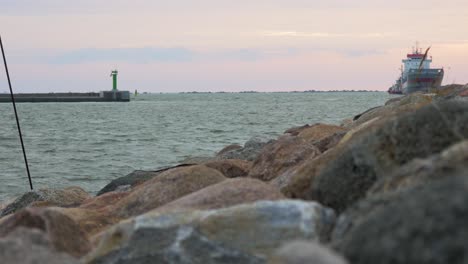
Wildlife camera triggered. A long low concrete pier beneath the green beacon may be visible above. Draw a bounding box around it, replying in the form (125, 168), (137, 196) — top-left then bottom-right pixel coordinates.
(0, 91), (130, 103)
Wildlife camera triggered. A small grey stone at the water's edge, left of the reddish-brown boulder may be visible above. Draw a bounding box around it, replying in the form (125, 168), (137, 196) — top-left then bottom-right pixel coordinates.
(217, 136), (273, 161)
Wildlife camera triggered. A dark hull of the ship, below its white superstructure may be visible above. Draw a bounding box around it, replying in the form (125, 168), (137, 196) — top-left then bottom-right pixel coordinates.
(402, 69), (444, 94)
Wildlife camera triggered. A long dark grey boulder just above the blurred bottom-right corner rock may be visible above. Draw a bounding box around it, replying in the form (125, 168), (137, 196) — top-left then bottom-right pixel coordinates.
(311, 101), (468, 212)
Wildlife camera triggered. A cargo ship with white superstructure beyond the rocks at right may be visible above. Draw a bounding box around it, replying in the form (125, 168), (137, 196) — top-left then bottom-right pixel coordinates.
(388, 45), (444, 94)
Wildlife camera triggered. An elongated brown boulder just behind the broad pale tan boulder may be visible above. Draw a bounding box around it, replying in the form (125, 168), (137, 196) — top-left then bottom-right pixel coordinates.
(113, 165), (226, 218)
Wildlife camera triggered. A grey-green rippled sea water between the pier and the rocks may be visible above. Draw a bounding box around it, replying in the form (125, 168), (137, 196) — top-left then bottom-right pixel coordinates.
(0, 92), (391, 201)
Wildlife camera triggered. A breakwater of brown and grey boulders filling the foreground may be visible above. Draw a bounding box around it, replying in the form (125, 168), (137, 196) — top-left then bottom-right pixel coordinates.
(0, 85), (468, 264)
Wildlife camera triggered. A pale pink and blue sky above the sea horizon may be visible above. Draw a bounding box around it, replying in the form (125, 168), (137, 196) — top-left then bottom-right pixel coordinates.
(0, 0), (468, 92)
